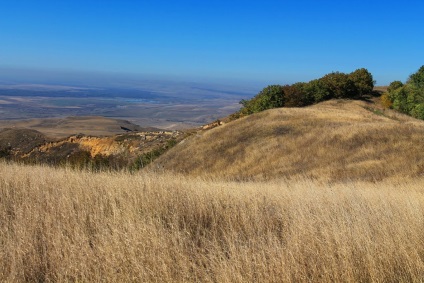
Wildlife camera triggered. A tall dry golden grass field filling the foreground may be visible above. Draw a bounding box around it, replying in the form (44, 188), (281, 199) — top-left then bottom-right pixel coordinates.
(0, 163), (424, 282)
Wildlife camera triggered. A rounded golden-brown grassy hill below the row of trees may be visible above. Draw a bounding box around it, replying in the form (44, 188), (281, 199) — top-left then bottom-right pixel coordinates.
(154, 100), (424, 181)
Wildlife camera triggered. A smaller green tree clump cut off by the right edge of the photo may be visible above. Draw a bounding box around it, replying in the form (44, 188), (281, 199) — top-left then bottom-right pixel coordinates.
(382, 66), (424, 119)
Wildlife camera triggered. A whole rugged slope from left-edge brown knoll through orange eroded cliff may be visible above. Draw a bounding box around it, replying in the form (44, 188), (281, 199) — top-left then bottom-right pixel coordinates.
(0, 128), (184, 169)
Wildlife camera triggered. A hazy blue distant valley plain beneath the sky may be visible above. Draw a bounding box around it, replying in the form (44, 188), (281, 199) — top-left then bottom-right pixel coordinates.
(0, 81), (256, 130)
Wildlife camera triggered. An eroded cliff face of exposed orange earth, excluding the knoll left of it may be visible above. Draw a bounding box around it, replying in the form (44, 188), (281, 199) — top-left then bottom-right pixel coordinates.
(2, 131), (184, 167)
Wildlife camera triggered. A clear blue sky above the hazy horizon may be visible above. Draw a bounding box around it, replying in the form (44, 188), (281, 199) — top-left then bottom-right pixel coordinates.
(0, 0), (424, 85)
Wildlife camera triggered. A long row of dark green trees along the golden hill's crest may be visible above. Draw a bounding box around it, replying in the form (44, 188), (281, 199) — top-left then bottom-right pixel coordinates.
(236, 68), (374, 117)
